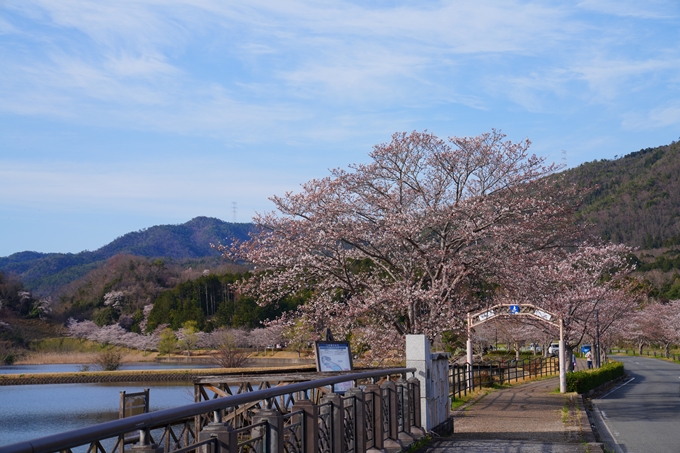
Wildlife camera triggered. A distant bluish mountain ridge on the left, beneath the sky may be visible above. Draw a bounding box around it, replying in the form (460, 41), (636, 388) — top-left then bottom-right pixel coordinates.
(0, 217), (253, 295)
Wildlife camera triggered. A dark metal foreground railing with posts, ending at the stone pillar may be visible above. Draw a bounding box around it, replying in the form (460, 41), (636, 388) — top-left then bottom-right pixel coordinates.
(0, 368), (424, 453)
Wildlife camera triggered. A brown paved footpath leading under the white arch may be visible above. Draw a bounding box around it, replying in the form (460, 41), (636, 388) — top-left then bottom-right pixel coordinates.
(427, 378), (602, 453)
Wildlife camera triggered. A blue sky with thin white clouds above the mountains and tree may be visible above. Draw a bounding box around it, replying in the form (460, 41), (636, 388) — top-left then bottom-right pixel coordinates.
(0, 0), (680, 256)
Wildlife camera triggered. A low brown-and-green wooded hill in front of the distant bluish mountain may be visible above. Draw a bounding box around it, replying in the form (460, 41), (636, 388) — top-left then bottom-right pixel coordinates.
(53, 254), (255, 331)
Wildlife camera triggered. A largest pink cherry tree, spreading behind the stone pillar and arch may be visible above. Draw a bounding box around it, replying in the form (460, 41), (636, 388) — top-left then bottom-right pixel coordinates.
(218, 130), (639, 357)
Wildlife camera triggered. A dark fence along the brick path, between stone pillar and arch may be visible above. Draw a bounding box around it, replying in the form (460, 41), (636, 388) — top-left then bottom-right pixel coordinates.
(449, 357), (560, 401)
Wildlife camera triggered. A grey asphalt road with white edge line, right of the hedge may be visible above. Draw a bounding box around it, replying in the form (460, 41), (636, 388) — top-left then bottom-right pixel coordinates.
(592, 357), (680, 453)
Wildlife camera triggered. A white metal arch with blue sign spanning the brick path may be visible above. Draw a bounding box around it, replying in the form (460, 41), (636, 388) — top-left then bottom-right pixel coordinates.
(467, 304), (567, 393)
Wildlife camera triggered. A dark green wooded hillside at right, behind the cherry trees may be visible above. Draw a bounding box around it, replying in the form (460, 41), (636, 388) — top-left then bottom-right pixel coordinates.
(563, 142), (680, 250)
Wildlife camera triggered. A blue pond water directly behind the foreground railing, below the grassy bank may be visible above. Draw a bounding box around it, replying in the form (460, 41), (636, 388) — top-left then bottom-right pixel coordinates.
(0, 382), (194, 445)
